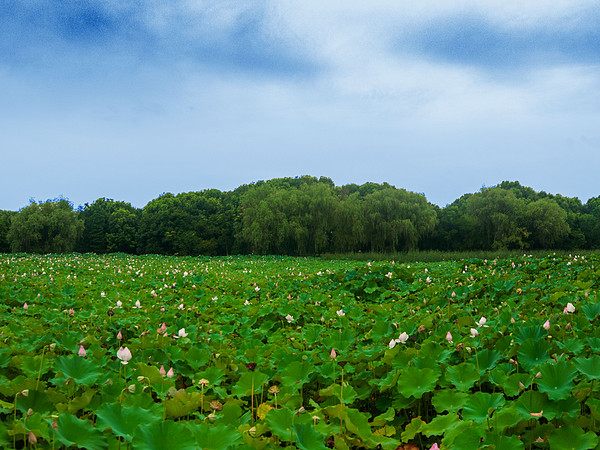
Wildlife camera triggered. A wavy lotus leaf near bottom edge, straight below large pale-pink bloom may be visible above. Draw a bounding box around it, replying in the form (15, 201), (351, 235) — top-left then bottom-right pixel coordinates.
(96, 403), (162, 442)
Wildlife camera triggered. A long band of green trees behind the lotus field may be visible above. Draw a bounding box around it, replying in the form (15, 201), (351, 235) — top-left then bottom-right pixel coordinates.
(0, 176), (600, 255)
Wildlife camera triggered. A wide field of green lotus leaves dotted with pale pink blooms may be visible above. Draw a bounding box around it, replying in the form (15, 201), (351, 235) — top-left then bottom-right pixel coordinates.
(0, 255), (600, 450)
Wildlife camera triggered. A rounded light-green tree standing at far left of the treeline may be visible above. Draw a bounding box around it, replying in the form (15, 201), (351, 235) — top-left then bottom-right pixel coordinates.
(7, 199), (83, 253)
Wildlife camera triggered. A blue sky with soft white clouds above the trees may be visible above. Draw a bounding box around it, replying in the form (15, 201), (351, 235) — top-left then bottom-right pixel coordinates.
(0, 0), (600, 210)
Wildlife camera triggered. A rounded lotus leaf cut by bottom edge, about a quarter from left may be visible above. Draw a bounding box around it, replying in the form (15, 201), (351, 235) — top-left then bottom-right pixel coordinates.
(131, 420), (198, 450)
